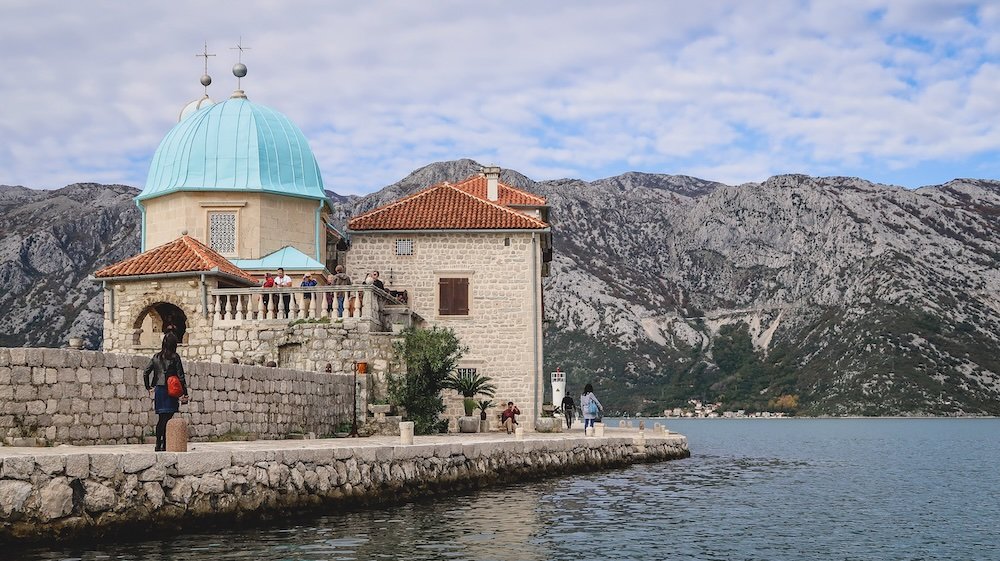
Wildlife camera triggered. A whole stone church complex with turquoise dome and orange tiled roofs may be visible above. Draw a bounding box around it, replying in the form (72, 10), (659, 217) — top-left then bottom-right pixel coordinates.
(93, 66), (552, 427)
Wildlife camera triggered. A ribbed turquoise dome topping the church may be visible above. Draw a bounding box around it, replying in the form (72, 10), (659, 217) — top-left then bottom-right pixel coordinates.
(137, 98), (326, 200)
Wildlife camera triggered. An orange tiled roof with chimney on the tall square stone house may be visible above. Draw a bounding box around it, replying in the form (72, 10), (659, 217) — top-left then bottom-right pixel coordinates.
(347, 177), (549, 231)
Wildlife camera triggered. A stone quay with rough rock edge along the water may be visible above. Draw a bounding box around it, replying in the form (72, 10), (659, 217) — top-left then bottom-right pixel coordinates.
(0, 432), (690, 543)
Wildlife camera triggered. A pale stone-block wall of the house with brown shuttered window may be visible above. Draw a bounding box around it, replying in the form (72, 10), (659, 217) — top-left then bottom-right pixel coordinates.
(348, 231), (545, 427)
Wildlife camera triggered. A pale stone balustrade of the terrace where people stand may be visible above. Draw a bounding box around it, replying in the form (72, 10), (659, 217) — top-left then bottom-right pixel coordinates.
(208, 285), (398, 325)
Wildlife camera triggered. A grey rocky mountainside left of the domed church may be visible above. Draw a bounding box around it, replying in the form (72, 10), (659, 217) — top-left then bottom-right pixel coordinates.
(0, 183), (139, 348)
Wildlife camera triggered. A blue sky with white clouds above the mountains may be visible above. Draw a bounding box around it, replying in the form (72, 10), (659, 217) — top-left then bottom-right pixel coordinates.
(0, 0), (1000, 194)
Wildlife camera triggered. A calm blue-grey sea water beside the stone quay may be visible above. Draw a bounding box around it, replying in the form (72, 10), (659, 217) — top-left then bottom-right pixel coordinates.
(15, 419), (1000, 561)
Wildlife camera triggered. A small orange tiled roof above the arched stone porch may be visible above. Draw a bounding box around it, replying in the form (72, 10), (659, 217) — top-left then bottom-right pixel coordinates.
(94, 236), (254, 282)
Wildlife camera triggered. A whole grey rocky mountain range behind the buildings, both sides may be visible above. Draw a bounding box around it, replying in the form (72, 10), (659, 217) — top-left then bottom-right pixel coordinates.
(0, 160), (1000, 415)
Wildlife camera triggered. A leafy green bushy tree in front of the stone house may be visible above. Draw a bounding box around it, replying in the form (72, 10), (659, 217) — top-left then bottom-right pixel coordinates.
(389, 327), (467, 434)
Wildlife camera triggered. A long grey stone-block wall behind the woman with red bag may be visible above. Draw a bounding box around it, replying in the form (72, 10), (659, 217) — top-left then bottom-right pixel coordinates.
(0, 348), (360, 445)
